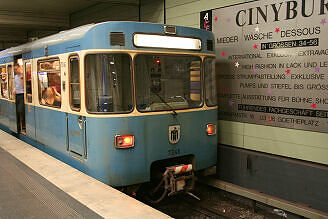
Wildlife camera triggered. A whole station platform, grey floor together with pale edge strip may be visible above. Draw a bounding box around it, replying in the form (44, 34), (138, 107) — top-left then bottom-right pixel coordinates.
(0, 130), (169, 218)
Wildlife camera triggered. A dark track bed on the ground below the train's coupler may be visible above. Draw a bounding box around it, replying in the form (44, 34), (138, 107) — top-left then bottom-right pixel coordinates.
(148, 184), (281, 219)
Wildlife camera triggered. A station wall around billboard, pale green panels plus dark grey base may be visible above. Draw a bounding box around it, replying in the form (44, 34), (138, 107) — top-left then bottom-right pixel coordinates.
(165, 0), (328, 212)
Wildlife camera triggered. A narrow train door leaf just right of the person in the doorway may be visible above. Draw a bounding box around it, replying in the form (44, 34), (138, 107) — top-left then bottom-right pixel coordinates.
(24, 60), (36, 139)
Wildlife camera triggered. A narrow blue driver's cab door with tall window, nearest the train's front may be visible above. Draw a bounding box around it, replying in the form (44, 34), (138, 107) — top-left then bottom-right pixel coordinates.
(66, 55), (87, 158)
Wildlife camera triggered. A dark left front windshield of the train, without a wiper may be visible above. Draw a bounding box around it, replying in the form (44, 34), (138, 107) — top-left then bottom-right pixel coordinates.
(85, 54), (133, 113)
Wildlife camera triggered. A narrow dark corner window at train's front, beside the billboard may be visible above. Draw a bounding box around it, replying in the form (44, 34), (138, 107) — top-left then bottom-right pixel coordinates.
(205, 58), (217, 106)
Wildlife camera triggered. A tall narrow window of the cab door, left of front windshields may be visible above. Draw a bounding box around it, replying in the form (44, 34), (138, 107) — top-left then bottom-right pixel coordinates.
(69, 56), (81, 111)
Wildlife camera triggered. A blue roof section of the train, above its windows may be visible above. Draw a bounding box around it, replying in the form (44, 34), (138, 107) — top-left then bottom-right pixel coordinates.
(0, 21), (214, 63)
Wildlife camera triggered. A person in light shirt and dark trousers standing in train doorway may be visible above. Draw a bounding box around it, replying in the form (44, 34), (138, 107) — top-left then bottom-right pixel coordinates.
(14, 63), (25, 133)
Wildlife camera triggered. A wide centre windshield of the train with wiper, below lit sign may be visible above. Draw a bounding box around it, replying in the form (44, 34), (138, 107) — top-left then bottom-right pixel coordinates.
(134, 54), (203, 112)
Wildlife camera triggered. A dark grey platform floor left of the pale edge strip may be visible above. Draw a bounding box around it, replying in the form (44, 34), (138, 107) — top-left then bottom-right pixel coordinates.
(0, 148), (101, 218)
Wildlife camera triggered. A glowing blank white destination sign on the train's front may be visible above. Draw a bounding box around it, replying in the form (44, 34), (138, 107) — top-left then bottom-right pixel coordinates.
(133, 34), (202, 50)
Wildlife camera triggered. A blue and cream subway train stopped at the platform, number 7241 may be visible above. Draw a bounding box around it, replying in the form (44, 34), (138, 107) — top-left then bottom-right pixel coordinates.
(0, 22), (217, 200)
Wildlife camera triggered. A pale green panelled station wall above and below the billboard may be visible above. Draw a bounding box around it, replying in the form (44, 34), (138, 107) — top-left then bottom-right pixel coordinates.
(166, 0), (328, 165)
